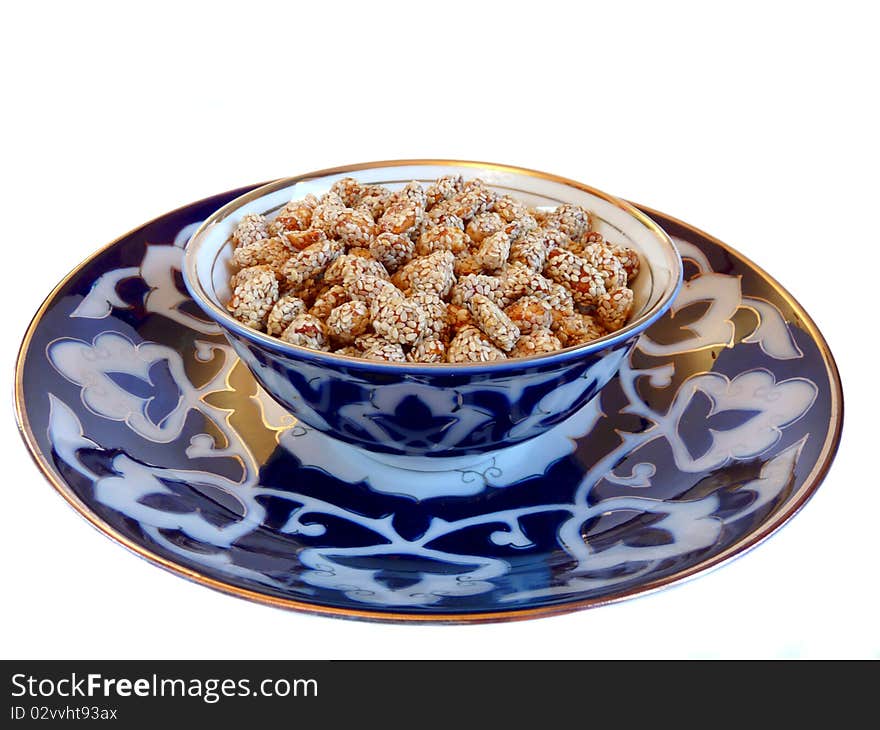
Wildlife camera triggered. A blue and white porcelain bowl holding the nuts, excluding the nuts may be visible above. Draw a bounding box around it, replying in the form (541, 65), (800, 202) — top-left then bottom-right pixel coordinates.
(183, 160), (682, 464)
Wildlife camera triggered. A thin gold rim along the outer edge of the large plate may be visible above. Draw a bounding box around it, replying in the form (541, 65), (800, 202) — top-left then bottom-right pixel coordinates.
(15, 191), (843, 624)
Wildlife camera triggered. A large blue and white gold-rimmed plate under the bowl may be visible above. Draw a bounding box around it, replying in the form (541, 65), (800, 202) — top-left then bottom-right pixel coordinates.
(15, 190), (843, 621)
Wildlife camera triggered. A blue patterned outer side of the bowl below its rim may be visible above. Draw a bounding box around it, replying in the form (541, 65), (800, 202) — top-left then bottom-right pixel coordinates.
(228, 326), (636, 458)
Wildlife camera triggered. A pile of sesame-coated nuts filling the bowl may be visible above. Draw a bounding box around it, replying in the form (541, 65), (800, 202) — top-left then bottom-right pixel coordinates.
(227, 175), (639, 363)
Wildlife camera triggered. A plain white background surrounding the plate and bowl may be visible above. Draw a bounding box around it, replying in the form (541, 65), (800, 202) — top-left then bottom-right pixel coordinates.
(0, 0), (880, 659)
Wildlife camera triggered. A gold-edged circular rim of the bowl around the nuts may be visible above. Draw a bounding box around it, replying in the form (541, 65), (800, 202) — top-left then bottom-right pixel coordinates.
(182, 159), (684, 375)
